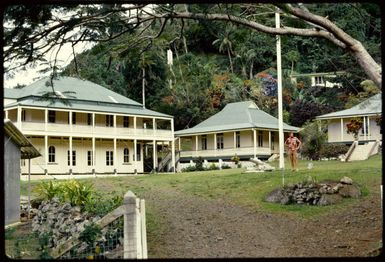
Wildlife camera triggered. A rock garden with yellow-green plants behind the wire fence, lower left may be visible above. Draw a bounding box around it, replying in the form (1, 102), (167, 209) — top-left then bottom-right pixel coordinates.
(21, 181), (123, 259)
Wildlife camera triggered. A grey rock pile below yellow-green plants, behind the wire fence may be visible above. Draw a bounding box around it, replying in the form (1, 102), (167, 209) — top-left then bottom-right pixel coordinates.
(32, 198), (123, 254)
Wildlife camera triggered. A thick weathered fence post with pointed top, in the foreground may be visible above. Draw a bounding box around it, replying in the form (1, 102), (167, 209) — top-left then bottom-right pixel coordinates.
(123, 191), (137, 259)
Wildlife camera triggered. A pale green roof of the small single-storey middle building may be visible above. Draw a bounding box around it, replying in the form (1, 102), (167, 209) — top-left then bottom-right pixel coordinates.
(175, 101), (299, 136)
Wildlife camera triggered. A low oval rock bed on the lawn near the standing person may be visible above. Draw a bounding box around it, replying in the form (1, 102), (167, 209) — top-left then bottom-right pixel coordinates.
(265, 177), (361, 205)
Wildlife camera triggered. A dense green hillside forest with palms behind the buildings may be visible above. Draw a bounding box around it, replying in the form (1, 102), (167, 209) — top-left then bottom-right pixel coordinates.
(58, 3), (381, 130)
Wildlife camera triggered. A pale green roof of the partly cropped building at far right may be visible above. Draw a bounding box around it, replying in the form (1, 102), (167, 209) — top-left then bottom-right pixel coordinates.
(317, 93), (382, 119)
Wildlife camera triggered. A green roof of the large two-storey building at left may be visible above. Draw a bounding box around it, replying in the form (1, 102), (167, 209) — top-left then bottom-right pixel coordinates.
(4, 77), (172, 118)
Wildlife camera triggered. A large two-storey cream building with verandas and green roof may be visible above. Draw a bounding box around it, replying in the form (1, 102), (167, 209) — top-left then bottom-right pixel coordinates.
(4, 77), (175, 174)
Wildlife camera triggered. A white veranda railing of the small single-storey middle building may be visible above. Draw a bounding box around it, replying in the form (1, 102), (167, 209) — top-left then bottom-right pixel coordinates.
(180, 147), (271, 157)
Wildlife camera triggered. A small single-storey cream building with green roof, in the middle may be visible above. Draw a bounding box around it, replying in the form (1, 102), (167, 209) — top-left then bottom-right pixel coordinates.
(175, 101), (299, 169)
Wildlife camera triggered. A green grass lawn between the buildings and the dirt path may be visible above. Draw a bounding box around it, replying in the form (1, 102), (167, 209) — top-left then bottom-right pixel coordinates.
(21, 155), (382, 217)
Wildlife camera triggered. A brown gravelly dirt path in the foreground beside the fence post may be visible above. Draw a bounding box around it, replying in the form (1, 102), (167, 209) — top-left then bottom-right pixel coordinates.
(144, 189), (382, 258)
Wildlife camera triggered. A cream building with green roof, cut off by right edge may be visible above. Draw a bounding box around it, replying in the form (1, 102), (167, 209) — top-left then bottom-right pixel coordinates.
(316, 93), (382, 144)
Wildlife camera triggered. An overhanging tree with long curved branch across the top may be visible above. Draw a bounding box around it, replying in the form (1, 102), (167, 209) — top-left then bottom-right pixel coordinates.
(3, 3), (382, 87)
